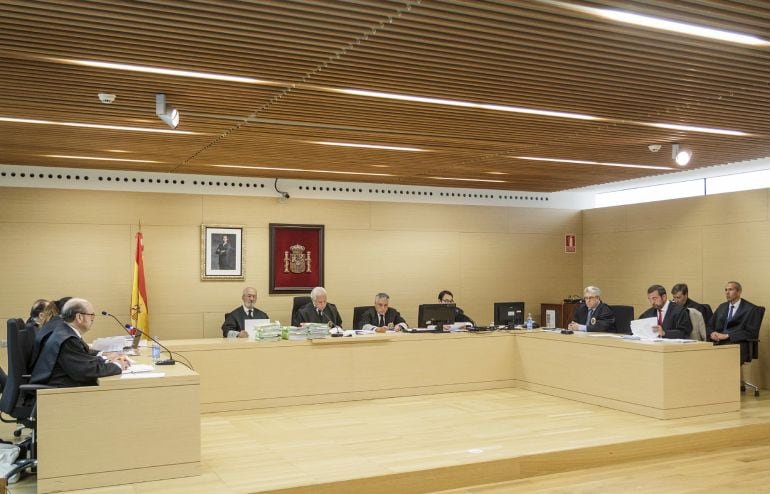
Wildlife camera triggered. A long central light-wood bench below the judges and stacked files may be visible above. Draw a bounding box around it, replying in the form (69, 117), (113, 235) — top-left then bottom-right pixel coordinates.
(166, 333), (515, 412)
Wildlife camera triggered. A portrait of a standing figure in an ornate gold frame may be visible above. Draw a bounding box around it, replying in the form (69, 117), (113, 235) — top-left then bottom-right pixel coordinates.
(201, 225), (244, 280)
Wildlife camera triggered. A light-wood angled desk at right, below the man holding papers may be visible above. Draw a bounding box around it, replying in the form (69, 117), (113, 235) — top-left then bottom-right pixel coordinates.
(516, 332), (740, 418)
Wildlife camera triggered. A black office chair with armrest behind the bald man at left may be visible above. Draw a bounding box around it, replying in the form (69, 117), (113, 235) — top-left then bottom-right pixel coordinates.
(0, 319), (50, 480)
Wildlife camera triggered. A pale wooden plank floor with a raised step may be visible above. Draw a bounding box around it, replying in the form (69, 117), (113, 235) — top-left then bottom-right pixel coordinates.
(8, 388), (770, 494)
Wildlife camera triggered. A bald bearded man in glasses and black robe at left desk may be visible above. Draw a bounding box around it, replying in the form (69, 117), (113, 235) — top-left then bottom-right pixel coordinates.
(30, 298), (129, 388)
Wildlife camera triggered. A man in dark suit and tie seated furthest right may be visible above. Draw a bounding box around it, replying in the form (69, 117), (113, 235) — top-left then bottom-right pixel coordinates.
(707, 281), (762, 362)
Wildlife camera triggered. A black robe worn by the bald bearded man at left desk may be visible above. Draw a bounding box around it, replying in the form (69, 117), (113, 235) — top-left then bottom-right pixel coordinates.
(30, 319), (122, 387)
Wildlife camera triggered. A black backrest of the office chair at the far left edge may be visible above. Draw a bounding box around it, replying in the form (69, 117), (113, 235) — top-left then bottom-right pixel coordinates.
(0, 319), (35, 419)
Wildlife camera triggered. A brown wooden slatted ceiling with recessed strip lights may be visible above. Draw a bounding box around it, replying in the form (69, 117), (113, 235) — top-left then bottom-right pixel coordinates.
(0, 0), (770, 191)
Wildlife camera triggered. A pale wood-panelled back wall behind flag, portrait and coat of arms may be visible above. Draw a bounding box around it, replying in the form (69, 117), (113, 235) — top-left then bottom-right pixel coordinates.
(0, 188), (582, 338)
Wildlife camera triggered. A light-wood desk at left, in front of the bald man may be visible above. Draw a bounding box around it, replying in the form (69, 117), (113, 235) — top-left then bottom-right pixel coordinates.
(37, 365), (200, 493)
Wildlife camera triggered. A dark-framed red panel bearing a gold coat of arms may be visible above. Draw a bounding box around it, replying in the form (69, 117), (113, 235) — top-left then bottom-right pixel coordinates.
(270, 223), (324, 293)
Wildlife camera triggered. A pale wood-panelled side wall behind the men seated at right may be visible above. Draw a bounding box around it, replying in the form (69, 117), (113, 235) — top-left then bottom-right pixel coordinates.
(578, 190), (770, 386)
